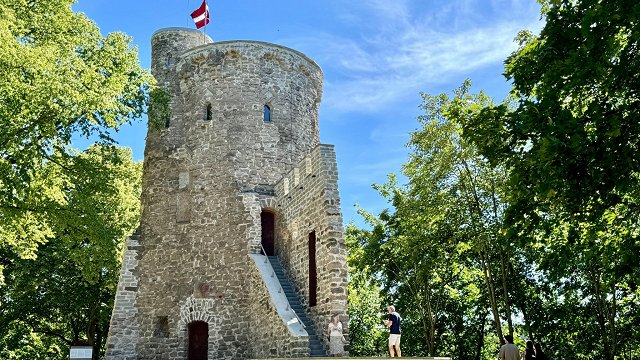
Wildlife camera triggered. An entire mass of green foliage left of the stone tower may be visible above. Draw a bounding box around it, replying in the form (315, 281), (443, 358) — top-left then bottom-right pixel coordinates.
(0, 0), (149, 359)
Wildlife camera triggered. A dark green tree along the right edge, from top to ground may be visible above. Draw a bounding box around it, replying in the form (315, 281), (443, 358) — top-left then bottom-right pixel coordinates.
(464, 0), (640, 359)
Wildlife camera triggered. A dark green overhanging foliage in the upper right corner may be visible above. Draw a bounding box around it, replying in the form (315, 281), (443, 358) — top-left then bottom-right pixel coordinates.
(465, 1), (640, 252)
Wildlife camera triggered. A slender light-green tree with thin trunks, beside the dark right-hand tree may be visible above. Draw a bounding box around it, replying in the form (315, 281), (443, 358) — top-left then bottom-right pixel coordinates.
(403, 81), (524, 346)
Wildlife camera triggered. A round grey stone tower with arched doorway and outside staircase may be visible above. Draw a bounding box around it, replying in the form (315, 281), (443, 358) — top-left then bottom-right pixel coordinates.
(106, 28), (348, 360)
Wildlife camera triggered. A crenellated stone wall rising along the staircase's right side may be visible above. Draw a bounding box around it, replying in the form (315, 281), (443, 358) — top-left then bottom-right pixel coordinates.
(275, 144), (348, 352)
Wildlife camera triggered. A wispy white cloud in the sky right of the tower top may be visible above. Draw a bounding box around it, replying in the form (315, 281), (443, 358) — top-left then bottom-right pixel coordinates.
(288, 0), (540, 112)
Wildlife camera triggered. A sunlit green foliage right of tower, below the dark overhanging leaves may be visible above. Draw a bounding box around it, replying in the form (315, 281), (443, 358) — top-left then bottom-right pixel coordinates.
(349, 62), (640, 359)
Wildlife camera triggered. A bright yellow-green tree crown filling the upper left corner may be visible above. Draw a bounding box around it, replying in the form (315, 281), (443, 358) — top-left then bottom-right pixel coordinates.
(0, 0), (153, 272)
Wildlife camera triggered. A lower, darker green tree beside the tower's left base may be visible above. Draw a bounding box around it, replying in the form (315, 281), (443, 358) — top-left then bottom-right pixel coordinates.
(0, 145), (142, 359)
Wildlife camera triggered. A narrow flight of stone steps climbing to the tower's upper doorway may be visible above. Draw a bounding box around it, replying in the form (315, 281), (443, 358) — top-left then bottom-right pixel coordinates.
(268, 256), (327, 357)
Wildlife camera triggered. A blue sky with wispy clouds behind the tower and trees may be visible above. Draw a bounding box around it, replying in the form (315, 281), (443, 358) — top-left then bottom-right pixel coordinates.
(73, 0), (543, 226)
